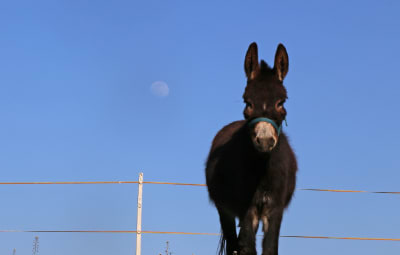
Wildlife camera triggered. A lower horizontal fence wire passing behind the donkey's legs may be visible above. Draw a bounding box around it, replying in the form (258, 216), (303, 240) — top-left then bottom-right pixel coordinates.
(0, 230), (400, 242)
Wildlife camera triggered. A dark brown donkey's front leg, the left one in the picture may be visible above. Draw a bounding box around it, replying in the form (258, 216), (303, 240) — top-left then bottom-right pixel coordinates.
(239, 207), (259, 255)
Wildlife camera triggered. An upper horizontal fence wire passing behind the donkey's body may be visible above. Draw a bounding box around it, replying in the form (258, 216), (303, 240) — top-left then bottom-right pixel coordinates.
(0, 181), (400, 195)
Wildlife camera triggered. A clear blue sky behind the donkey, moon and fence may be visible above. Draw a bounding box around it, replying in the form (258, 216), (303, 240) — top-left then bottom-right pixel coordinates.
(0, 0), (400, 255)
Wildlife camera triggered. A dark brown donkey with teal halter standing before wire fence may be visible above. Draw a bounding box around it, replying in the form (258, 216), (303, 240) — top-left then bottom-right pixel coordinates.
(205, 43), (297, 255)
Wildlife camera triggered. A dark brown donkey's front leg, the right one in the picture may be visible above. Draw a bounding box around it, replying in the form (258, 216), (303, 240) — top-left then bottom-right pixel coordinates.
(262, 210), (283, 255)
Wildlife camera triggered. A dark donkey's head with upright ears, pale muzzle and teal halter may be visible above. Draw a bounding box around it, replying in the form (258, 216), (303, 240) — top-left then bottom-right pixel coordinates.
(243, 43), (289, 152)
